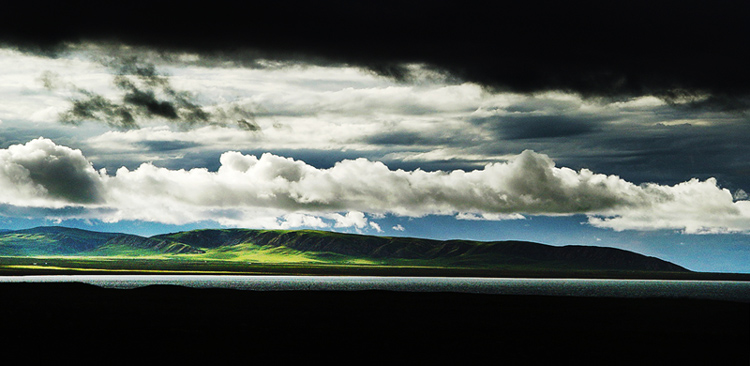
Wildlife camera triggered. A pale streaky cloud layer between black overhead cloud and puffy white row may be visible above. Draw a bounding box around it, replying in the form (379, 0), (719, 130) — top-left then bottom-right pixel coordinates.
(5, 45), (750, 223)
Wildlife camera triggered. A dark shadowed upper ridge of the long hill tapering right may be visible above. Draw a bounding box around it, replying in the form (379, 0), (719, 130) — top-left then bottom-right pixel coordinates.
(152, 229), (687, 271)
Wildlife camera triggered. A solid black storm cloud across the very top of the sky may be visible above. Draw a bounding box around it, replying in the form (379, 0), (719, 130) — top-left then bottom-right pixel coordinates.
(0, 0), (750, 109)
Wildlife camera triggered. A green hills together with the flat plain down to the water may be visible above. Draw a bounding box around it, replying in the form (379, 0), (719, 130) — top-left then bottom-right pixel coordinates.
(0, 227), (748, 278)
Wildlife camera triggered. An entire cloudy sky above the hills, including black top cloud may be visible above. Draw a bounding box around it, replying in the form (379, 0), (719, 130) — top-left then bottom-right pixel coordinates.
(0, 1), (750, 273)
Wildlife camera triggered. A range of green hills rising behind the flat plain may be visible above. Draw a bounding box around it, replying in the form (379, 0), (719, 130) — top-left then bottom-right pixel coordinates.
(0, 226), (688, 272)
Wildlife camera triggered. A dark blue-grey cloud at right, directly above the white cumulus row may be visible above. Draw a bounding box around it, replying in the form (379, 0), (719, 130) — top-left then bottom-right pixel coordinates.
(471, 122), (750, 196)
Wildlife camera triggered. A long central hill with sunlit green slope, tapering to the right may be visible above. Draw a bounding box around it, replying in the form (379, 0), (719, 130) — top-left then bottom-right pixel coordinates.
(157, 229), (684, 271)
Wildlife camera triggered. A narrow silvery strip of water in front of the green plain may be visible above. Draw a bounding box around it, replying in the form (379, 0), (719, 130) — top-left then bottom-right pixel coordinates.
(0, 275), (750, 302)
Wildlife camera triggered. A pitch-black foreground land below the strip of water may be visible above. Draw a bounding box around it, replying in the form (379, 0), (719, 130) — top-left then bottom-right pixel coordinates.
(0, 283), (750, 365)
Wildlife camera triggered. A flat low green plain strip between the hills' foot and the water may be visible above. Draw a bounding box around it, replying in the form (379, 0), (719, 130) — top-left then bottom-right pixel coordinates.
(0, 253), (750, 281)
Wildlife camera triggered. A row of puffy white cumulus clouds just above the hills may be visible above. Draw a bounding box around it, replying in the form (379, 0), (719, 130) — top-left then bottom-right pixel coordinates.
(0, 138), (750, 233)
